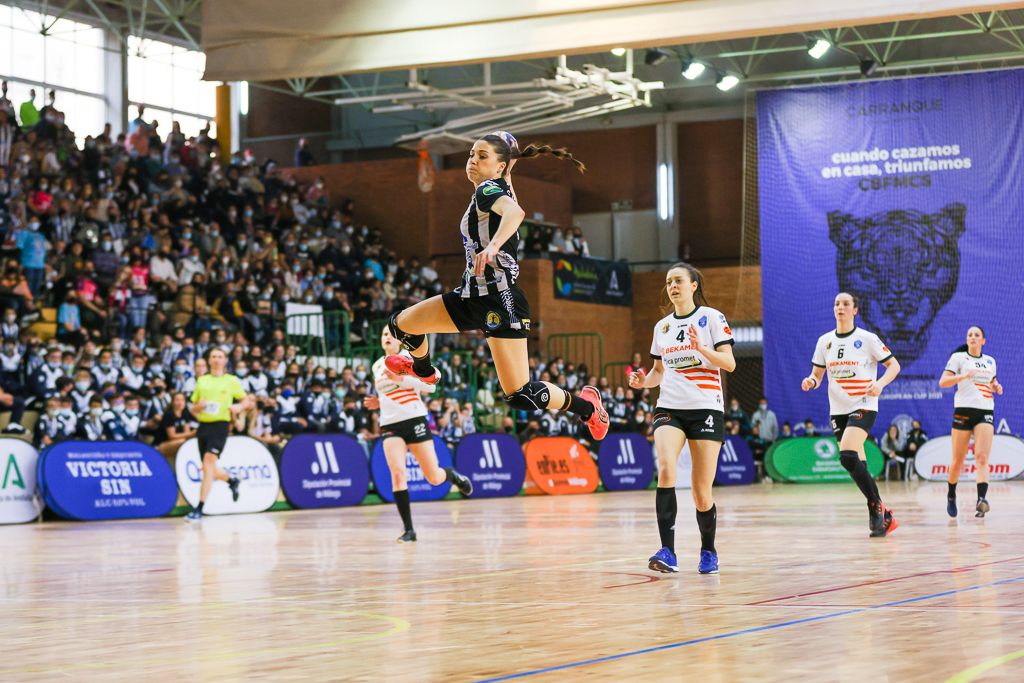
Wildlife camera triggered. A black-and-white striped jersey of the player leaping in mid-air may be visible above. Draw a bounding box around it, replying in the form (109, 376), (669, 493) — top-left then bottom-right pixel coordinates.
(455, 178), (519, 299)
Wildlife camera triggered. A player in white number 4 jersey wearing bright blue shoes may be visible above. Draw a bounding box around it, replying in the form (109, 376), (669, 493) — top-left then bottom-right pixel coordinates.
(630, 263), (736, 573)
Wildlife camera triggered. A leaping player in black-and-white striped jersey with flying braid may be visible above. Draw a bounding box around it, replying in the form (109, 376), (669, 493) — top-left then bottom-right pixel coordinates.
(386, 131), (608, 441)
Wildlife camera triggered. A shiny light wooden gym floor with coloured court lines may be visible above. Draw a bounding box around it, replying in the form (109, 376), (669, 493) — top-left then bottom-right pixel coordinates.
(0, 482), (1024, 683)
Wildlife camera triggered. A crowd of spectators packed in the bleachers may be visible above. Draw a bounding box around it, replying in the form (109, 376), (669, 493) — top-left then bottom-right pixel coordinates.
(0, 90), (650, 452)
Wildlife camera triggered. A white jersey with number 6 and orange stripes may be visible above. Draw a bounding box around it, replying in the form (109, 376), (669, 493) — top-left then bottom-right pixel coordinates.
(811, 328), (893, 415)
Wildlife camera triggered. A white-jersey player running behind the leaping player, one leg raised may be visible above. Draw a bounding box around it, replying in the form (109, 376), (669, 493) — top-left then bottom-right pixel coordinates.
(364, 328), (473, 543)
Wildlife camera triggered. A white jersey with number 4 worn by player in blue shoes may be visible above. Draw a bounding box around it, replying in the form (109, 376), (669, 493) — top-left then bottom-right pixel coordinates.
(650, 306), (733, 411)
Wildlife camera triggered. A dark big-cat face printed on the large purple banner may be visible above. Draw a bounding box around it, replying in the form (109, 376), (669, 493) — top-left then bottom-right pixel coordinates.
(828, 203), (967, 366)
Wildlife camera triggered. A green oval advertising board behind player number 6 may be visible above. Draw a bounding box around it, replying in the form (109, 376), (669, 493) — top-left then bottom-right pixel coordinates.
(765, 436), (885, 483)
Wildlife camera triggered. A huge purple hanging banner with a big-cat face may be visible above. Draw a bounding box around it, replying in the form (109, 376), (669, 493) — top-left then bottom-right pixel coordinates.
(758, 71), (1024, 435)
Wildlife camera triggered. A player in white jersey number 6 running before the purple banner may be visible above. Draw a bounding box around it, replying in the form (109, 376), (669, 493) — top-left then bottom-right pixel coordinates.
(801, 292), (899, 538)
